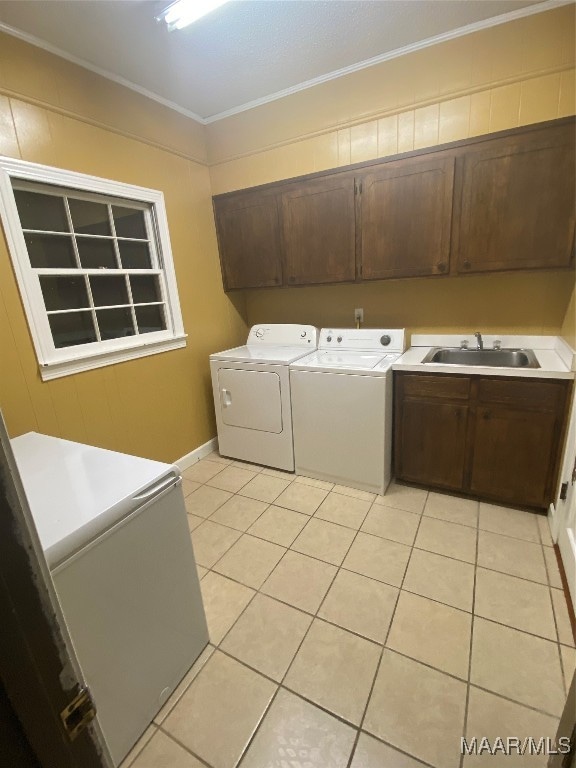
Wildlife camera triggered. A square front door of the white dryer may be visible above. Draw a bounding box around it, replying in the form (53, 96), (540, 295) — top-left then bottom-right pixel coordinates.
(218, 368), (282, 434)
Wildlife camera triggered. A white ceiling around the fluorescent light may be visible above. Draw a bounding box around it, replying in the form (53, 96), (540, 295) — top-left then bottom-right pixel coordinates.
(0, 0), (570, 122)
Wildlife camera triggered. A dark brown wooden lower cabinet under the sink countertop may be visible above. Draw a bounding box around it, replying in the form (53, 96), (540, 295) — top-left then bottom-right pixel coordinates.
(394, 371), (572, 508)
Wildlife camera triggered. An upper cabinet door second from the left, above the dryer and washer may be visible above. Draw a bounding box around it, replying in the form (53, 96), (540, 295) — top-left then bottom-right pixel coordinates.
(282, 175), (356, 285)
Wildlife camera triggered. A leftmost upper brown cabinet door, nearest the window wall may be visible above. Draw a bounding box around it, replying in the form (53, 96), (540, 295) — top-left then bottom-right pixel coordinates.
(214, 191), (282, 291)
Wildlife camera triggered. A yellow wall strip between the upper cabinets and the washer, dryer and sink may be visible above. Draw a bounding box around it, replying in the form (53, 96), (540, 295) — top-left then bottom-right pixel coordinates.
(248, 272), (574, 335)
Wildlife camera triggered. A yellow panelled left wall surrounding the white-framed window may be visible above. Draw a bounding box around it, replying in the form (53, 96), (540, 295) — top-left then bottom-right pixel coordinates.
(0, 36), (246, 461)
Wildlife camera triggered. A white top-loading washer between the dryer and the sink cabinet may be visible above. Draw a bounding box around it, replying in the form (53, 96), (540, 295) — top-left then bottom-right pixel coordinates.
(290, 328), (404, 494)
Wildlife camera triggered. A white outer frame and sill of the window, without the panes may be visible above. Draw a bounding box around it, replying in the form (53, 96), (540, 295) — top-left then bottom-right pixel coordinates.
(0, 156), (186, 381)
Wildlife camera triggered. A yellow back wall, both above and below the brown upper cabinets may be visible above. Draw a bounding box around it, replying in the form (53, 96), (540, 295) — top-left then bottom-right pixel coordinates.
(207, 5), (576, 334)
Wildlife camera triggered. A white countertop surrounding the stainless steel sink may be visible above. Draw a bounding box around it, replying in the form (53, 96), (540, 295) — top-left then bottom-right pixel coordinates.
(392, 334), (576, 379)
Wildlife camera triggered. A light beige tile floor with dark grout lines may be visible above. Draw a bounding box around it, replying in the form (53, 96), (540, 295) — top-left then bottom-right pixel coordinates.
(123, 454), (576, 768)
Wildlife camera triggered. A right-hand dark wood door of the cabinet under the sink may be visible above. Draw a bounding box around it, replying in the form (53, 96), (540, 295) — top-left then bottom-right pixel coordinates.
(470, 405), (556, 507)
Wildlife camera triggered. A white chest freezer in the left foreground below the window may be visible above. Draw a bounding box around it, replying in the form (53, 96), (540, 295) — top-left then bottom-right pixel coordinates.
(11, 432), (208, 765)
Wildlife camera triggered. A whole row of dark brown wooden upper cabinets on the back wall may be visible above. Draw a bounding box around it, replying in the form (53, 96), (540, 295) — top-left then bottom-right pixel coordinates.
(214, 118), (576, 290)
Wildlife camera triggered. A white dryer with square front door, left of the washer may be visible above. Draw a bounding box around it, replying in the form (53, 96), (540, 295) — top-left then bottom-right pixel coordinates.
(210, 323), (318, 472)
